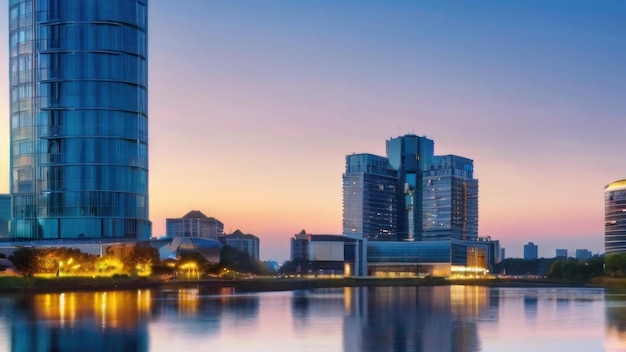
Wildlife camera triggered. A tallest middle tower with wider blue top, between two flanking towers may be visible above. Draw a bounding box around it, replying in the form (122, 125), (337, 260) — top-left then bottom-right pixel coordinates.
(387, 134), (434, 241)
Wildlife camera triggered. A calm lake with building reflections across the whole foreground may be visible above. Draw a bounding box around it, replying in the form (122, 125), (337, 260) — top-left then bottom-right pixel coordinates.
(0, 286), (626, 352)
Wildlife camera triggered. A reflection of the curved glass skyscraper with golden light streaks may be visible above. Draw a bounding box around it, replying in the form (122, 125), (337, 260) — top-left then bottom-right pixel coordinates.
(10, 291), (151, 351)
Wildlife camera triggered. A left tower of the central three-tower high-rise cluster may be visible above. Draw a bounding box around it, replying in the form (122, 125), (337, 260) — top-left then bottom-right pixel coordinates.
(343, 154), (397, 240)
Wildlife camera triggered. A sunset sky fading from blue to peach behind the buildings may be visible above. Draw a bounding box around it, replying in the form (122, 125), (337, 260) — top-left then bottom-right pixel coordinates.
(0, 0), (626, 262)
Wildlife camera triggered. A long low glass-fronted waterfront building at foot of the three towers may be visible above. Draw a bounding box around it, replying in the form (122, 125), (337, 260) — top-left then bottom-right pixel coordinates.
(291, 230), (499, 277)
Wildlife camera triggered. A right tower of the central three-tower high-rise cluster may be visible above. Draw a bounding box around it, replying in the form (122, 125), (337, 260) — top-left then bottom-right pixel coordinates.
(422, 155), (478, 241)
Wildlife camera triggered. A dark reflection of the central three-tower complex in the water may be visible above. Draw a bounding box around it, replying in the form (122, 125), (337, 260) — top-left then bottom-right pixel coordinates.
(292, 286), (490, 352)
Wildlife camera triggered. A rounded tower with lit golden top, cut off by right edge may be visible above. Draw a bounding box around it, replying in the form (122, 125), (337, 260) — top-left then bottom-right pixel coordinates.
(604, 179), (626, 254)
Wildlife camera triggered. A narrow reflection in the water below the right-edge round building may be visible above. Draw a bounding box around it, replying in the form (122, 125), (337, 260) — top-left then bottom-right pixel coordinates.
(604, 289), (626, 351)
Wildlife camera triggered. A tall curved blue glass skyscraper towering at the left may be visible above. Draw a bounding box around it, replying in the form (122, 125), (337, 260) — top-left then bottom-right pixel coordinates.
(9, 0), (151, 239)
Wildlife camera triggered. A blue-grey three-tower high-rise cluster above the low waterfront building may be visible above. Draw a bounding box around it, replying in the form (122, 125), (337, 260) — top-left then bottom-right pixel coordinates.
(343, 135), (478, 242)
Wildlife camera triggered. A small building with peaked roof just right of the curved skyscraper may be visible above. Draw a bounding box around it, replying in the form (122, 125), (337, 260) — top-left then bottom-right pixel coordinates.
(165, 210), (224, 239)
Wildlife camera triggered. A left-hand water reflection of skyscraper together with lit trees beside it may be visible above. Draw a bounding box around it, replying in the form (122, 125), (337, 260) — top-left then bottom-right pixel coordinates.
(0, 288), (259, 352)
